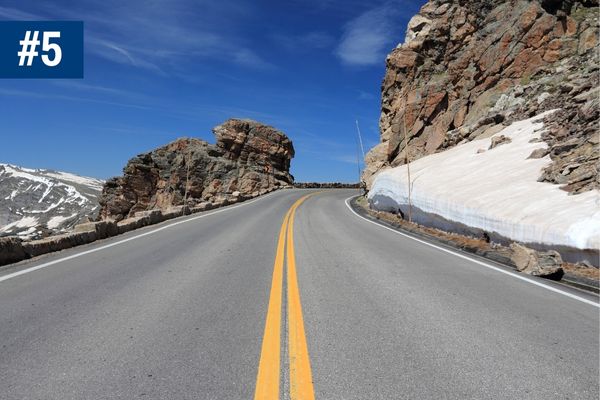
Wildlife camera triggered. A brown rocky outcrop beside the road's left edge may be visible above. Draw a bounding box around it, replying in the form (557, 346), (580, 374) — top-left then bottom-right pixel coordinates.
(100, 119), (294, 220)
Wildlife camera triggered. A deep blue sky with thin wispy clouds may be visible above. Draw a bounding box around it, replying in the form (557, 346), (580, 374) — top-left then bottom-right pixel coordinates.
(0, 0), (424, 182)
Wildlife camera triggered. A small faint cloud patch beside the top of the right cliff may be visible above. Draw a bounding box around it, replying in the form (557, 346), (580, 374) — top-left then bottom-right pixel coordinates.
(335, 2), (399, 66)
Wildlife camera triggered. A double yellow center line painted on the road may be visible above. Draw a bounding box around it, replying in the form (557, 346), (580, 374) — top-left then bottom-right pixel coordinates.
(254, 194), (315, 400)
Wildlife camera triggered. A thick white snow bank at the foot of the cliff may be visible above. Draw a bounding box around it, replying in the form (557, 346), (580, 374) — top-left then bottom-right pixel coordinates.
(368, 111), (600, 249)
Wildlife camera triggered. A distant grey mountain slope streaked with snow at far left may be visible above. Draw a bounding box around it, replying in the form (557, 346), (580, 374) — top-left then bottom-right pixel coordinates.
(0, 163), (104, 238)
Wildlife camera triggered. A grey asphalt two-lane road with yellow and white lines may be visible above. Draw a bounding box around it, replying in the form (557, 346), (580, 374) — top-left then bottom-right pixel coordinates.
(0, 190), (599, 400)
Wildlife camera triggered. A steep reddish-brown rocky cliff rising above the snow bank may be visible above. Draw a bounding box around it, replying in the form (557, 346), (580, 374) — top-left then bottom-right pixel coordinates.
(363, 0), (600, 193)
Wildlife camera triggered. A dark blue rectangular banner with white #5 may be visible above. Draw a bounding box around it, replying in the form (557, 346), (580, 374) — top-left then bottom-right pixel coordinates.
(0, 21), (83, 79)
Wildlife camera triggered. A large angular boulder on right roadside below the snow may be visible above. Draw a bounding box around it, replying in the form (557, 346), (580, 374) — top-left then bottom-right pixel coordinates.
(510, 243), (564, 279)
